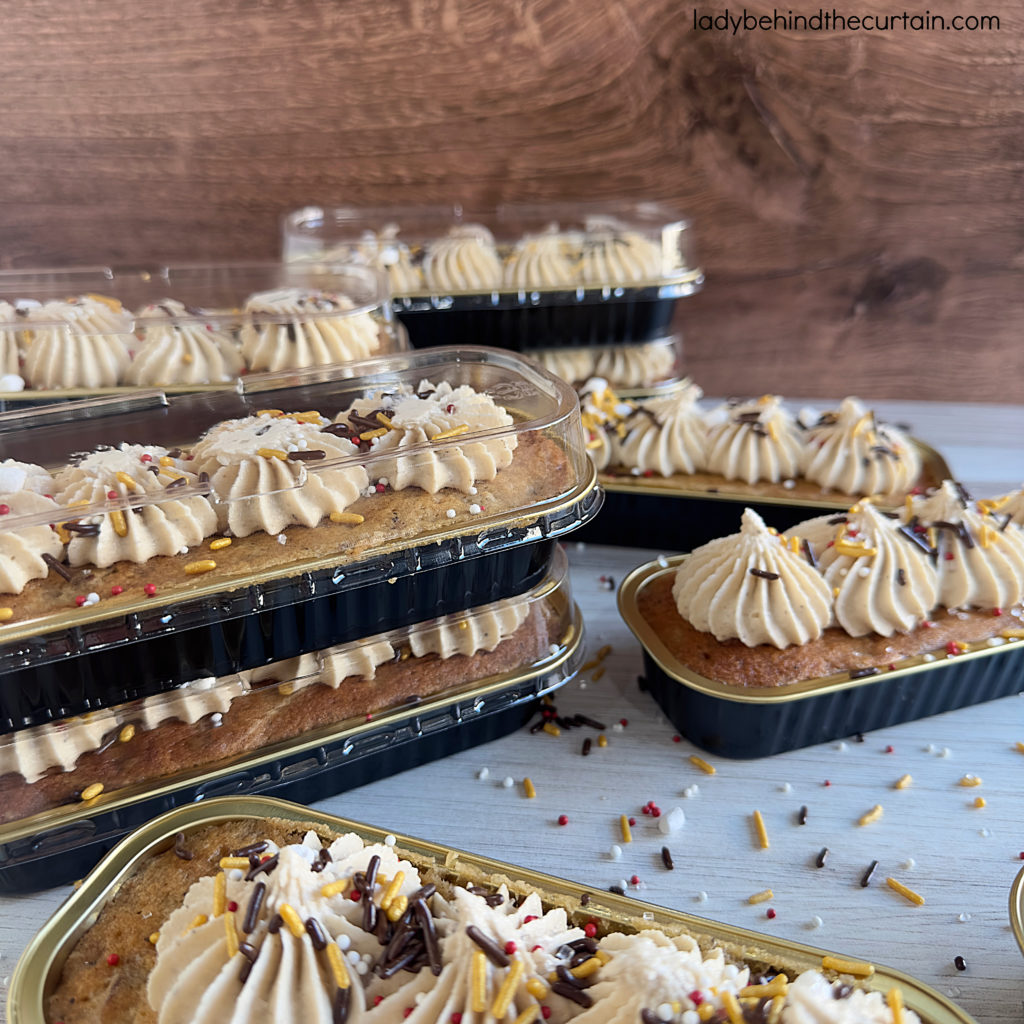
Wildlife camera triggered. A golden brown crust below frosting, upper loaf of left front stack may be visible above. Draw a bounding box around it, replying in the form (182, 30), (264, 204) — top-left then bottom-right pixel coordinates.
(0, 431), (571, 626)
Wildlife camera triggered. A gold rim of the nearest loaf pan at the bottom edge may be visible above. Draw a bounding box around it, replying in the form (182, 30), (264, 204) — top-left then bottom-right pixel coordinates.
(7, 798), (973, 1024)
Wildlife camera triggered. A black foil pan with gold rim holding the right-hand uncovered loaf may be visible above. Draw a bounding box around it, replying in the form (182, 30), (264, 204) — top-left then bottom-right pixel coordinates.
(618, 555), (1024, 758)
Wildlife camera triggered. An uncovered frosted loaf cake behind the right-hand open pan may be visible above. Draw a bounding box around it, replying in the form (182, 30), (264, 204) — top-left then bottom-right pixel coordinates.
(581, 378), (938, 504)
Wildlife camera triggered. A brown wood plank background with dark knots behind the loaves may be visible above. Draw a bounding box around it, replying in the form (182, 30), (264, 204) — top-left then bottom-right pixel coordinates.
(0, 0), (1024, 402)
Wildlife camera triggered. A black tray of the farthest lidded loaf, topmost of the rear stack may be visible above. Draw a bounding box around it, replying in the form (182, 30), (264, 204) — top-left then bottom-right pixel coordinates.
(393, 284), (699, 353)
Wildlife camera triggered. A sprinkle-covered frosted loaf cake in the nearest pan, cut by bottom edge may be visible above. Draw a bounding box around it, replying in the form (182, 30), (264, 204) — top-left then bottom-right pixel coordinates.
(46, 819), (921, 1024)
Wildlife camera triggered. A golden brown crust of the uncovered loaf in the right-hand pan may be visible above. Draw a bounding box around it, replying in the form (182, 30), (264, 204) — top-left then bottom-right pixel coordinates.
(637, 573), (1008, 686)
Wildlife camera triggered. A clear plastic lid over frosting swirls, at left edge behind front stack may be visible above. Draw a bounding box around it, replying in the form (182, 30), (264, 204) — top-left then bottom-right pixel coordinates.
(0, 262), (404, 400)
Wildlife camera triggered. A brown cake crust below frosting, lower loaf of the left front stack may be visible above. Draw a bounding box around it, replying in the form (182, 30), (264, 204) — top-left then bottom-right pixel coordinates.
(0, 601), (558, 821)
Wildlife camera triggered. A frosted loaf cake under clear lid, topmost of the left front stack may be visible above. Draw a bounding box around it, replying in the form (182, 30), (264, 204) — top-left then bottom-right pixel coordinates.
(0, 381), (574, 641)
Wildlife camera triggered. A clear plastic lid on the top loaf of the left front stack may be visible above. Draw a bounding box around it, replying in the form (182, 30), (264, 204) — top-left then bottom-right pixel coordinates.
(0, 348), (596, 647)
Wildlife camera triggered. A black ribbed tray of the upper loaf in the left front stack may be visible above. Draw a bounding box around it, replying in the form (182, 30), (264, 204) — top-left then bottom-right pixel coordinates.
(0, 539), (555, 732)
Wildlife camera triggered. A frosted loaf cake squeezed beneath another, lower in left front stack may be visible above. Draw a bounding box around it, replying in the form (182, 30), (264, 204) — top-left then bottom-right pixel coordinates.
(0, 589), (561, 822)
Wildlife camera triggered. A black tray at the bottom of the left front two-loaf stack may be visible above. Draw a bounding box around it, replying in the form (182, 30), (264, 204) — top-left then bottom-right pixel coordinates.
(0, 643), (583, 893)
